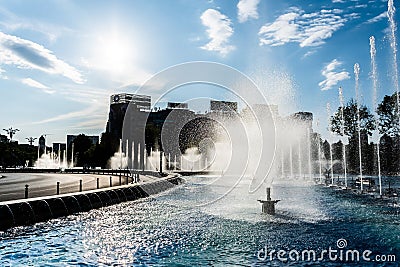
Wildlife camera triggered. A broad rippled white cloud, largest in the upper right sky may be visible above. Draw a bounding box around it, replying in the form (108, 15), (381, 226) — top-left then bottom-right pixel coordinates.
(258, 8), (346, 47)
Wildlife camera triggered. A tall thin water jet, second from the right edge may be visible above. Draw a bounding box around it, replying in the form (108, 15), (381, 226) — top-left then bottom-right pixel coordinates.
(369, 36), (382, 196)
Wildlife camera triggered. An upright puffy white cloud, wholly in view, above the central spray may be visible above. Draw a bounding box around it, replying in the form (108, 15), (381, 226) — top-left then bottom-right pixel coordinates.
(200, 9), (235, 56)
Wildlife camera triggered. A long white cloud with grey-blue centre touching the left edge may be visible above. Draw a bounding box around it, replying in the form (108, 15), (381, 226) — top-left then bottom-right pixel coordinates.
(0, 32), (84, 84)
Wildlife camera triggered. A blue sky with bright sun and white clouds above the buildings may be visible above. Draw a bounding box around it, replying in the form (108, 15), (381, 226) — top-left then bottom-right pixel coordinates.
(0, 0), (400, 146)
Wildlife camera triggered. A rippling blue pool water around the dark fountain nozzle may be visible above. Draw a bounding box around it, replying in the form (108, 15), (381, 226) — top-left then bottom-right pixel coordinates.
(0, 176), (400, 266)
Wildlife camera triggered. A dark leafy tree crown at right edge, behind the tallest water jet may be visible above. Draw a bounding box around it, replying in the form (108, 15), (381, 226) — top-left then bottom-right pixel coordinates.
(377, 93), (399, 137)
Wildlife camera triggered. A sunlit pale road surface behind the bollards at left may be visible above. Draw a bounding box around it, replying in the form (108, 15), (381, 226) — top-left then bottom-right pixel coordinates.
(0, 173), (151, 201)
